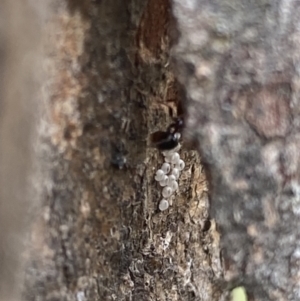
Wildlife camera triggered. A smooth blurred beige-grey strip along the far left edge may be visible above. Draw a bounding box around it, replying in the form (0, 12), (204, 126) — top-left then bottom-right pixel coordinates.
(0, 1), (40, 301)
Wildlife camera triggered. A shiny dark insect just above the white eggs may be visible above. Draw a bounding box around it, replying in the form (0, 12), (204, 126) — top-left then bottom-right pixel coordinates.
(151, 98), (184, 151)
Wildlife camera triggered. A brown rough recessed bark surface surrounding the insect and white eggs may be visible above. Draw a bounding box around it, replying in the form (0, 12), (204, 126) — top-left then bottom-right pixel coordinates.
(19, 0), (222, 301)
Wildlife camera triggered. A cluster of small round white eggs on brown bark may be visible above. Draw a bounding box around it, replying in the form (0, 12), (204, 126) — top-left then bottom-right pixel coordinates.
(155, 150), (185, 211)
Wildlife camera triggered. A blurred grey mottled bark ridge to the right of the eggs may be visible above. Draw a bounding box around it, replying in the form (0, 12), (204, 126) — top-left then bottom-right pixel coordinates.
(173, 0), (300, 301)
